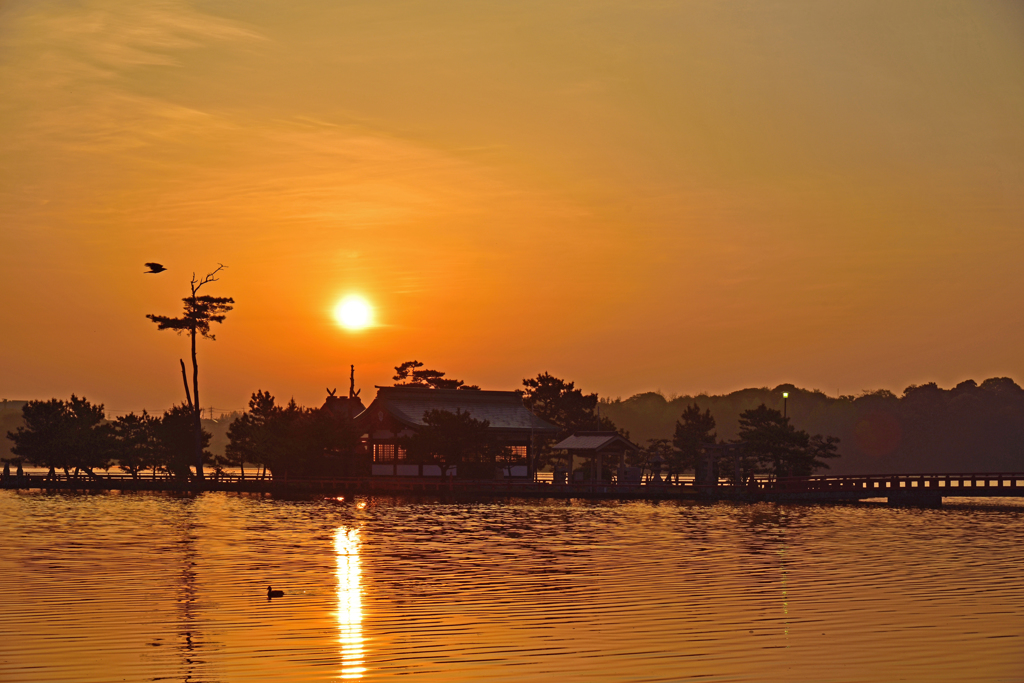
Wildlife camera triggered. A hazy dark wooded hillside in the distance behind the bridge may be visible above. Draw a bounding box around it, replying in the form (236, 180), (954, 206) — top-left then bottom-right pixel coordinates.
(601, 377), (1024, 474)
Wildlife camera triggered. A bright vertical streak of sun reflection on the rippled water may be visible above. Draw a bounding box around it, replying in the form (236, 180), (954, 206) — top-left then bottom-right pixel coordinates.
(334, 526), (366, 679)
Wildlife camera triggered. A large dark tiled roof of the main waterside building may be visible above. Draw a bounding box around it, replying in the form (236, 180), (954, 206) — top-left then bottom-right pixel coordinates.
(357, 387), (559, 433)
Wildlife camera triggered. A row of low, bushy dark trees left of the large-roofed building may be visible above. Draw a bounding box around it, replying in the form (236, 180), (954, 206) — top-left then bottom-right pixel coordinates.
(5, 391), (361, 480)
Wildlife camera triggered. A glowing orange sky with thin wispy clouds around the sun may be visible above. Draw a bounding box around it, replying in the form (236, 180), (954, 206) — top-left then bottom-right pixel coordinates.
(0, 0), (1024, 413)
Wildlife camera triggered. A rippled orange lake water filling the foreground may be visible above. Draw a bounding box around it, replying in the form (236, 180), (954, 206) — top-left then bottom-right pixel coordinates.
(0, 492), (1024, 683)
